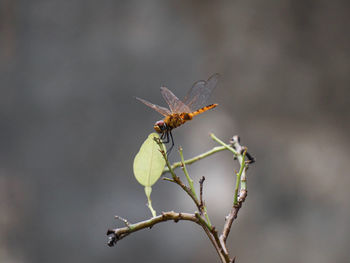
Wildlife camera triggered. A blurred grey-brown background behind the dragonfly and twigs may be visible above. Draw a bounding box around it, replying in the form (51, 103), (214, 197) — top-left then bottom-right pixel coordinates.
(0, 0), (350, 263)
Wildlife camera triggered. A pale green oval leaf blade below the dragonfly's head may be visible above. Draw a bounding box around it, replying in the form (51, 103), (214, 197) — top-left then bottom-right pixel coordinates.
(134, 133), (165, 186)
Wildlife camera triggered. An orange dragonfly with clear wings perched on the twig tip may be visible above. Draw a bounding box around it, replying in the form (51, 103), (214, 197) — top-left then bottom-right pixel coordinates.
(136, 73), (219, 153)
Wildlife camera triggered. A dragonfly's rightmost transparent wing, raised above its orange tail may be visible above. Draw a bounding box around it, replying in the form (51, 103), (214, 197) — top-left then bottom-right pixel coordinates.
(184, 73), (220, 111)
